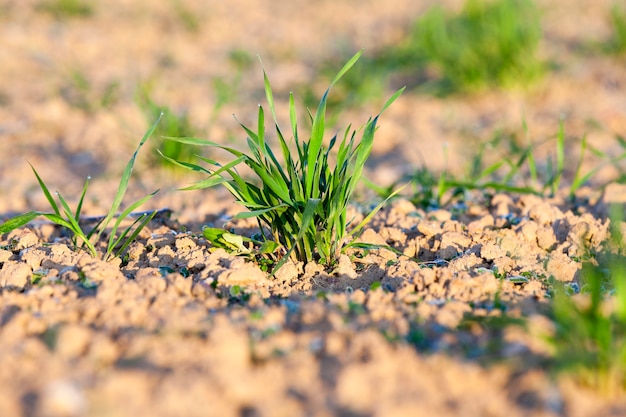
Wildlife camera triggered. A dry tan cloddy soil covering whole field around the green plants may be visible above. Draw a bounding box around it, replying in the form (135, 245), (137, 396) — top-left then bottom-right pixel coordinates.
(0, 0), (626, 417)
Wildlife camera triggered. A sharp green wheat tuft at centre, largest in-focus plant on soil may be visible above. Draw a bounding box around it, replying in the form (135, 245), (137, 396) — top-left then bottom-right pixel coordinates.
(167, 51), (403, 270)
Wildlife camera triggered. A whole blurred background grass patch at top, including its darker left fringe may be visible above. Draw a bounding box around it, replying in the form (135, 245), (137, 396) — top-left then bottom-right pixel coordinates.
(314, 0), (544, 106)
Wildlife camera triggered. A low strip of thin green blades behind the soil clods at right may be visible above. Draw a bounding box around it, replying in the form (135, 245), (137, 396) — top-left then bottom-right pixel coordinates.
(392, 122), (626, 207)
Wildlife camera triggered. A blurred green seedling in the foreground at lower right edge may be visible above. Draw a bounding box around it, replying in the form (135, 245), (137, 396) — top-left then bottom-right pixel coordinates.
(550, 207), (626, 395)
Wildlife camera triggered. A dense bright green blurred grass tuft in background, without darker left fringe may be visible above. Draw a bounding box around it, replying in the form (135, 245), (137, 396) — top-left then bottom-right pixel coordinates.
(405, 0), (541, 91)
